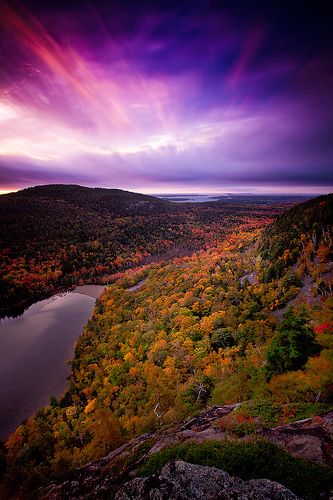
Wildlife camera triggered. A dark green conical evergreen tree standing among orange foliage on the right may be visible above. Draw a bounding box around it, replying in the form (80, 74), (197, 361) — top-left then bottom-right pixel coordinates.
(266, 307), (320, 379)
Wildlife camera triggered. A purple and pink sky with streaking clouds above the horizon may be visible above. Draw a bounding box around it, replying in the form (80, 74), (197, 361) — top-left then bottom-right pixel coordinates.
(0, 0), (333, 194)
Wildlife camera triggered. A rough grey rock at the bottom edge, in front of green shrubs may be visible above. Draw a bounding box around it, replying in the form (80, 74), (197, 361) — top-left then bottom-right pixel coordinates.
(115, 461), (298, 500)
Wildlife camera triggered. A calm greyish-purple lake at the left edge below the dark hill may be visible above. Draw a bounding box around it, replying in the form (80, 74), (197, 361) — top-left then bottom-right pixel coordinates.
(0, 285), (104, 439)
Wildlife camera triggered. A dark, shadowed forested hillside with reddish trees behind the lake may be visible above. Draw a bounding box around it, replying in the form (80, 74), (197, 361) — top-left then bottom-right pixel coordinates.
(0, 185), (291, 317)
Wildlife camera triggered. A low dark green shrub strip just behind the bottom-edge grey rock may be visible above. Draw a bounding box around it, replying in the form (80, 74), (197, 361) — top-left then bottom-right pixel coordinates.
(138, 439), (333, 499)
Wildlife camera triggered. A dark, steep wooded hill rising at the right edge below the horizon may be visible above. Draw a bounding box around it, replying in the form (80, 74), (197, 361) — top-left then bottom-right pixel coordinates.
(260, 194), (333, 295)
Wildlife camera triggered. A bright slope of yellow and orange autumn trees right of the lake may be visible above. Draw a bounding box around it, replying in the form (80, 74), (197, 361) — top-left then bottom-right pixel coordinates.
(1, 192), (333, 500)
